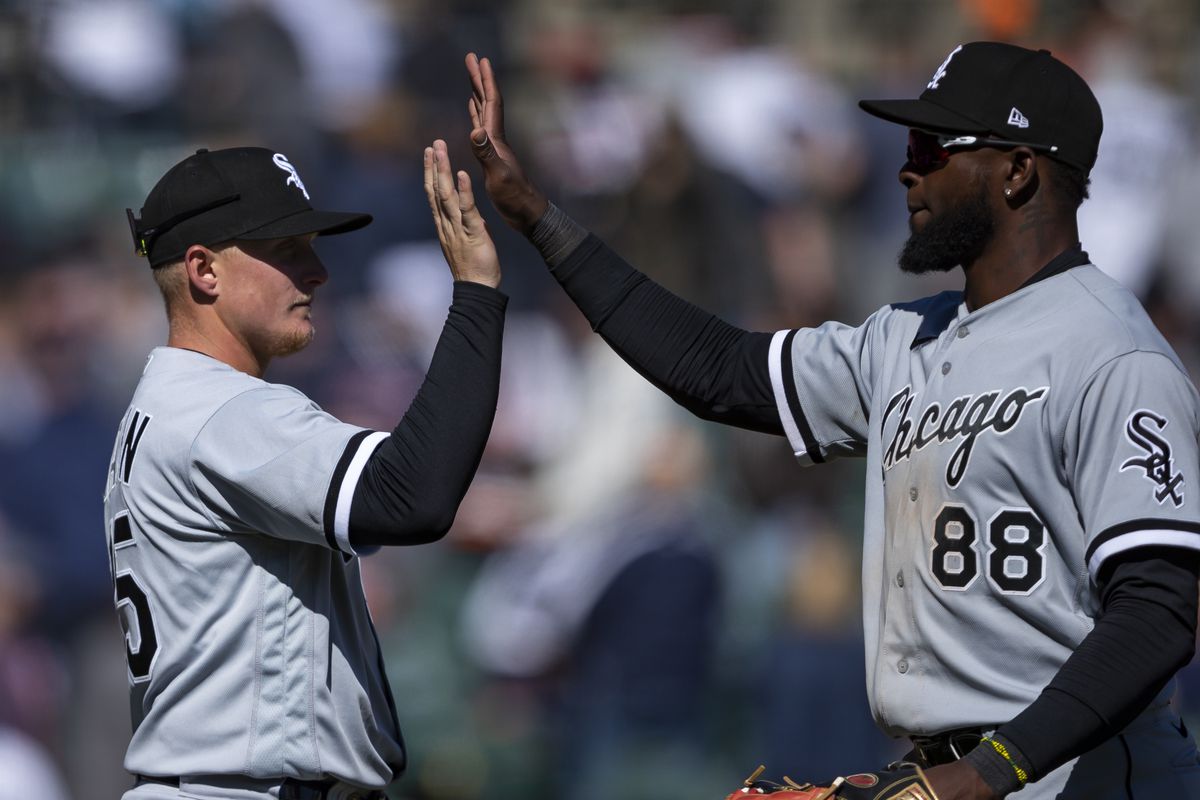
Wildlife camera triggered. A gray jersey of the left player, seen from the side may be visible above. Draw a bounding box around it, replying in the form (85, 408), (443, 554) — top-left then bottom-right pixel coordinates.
(104, 348), (404, 787)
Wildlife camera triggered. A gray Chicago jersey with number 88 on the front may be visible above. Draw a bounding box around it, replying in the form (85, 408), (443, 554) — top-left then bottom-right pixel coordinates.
(769, 265), (1200, 735)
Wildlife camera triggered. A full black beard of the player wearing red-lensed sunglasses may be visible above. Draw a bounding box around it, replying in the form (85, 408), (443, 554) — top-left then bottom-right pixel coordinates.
(900, 184), (996, 275)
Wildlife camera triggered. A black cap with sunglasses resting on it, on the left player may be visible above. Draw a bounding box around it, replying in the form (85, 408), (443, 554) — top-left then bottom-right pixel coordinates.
(125, 148), (371, 266)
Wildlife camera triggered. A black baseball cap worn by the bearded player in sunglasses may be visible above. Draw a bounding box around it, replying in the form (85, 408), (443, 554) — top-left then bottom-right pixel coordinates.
(858, 42), (1104, 173)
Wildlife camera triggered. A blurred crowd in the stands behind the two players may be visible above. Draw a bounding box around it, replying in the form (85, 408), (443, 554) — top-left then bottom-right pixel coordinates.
(0, 0), (1200, 800)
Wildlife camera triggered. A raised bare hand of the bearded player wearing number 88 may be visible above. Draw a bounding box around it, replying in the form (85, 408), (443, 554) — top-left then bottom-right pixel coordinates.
(467, 53), (548, 234)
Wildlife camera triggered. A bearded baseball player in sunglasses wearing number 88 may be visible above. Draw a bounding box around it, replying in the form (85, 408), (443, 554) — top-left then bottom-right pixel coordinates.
(467, 42), (1200, 800)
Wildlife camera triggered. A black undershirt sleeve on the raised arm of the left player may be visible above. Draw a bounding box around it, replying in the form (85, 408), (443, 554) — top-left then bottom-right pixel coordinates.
(349, 282), (508, 548)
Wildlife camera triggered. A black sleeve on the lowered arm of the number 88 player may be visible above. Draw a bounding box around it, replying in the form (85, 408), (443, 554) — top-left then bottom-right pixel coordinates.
(967, 547), (1200, 796)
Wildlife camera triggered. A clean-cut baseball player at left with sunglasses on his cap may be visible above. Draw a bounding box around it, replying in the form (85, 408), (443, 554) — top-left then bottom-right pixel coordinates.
(104, 142), (506, 800)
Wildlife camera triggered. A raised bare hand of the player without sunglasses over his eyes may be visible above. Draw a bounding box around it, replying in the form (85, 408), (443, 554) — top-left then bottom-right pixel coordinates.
(425, 139), (500, 288)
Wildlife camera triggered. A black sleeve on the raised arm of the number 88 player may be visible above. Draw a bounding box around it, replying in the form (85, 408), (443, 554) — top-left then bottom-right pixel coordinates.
(530, 205), (784, 434)
